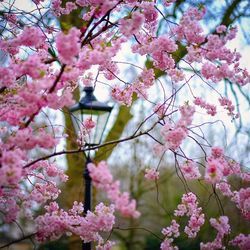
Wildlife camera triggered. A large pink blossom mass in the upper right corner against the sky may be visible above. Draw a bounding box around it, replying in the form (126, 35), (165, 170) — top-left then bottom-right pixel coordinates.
(175, 8), (250, 86)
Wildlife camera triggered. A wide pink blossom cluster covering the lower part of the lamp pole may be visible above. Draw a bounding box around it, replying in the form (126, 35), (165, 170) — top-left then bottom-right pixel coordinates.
(35, 201), (115, 244)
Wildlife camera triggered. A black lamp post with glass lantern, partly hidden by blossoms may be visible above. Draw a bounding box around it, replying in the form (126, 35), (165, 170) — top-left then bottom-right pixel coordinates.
(70, 87), (113, 250)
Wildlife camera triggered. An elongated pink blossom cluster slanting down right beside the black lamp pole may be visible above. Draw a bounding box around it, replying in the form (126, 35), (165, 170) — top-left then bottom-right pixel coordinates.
(88, 161), (140, 218)
